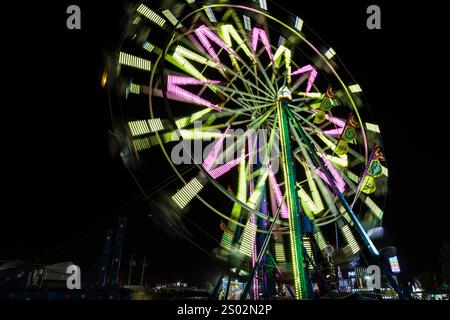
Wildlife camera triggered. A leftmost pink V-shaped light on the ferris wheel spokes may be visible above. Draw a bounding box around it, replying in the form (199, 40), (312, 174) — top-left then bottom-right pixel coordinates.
(167, 75), (222, 111)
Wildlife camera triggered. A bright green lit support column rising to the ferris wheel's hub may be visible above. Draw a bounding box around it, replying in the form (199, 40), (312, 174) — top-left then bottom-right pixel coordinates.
(277, 87), (311, 299)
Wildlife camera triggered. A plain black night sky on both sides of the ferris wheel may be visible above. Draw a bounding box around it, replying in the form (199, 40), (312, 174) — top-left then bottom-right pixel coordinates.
(0, 0), (449, 283)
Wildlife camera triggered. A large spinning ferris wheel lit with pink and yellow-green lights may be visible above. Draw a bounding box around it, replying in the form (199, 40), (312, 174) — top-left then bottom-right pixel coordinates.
(102, 0), (400, 299)
